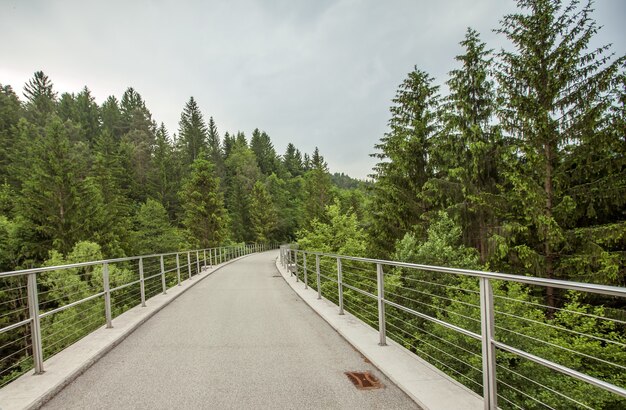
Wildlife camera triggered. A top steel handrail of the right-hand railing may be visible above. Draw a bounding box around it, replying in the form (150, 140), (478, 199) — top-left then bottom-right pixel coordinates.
(283, 245), (626, 297)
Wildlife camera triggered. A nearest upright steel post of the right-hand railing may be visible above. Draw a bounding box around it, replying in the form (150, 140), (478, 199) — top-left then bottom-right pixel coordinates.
(480, 277), (498, 410)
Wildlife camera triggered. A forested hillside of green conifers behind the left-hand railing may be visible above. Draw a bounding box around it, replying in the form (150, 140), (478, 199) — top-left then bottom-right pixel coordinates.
(0, 75), (360, 271)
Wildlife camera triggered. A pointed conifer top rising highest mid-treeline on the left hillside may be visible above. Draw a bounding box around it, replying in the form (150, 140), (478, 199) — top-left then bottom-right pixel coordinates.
(178, 97), (208, 165)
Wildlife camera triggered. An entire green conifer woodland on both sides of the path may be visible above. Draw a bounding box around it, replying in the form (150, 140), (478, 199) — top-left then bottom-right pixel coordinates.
(0, 0), (626, 408)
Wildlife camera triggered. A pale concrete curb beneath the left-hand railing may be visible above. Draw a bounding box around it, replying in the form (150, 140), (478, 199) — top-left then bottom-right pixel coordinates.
(0, 255), (250, 410)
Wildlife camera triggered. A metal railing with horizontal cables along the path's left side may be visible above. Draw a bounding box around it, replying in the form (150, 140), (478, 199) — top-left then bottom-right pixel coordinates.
(0, 244), (276, 387)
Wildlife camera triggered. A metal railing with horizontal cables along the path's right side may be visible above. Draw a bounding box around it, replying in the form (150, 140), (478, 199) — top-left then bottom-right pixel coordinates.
(279, 245), (626, 409)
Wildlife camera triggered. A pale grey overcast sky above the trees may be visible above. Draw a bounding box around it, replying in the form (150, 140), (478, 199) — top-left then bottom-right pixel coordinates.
(0, 0), (626, 178)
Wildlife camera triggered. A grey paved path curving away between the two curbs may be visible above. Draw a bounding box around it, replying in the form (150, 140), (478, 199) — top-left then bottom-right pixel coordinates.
(44, 252), (417, 409)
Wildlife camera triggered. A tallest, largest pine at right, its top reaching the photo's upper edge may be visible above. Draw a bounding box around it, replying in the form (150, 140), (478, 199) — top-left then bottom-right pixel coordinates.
(497, 0), (624, 300)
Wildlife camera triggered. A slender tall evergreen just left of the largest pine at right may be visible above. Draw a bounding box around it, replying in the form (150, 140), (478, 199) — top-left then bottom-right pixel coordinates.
(428, 28), (502, 263)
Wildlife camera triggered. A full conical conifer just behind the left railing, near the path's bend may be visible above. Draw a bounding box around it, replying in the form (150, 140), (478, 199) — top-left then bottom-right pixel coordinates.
(180, 158), (228, 248)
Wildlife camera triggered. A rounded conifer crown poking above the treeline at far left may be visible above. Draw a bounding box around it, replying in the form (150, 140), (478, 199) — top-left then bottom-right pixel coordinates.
(24, 71), (57, 127)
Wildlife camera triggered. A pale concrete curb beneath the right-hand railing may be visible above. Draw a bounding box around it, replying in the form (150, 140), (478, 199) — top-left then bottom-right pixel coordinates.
(276, 259), (484, 410)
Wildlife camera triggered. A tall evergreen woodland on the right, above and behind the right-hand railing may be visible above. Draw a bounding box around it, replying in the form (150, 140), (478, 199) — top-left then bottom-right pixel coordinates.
(299, 0), (626, 409)
